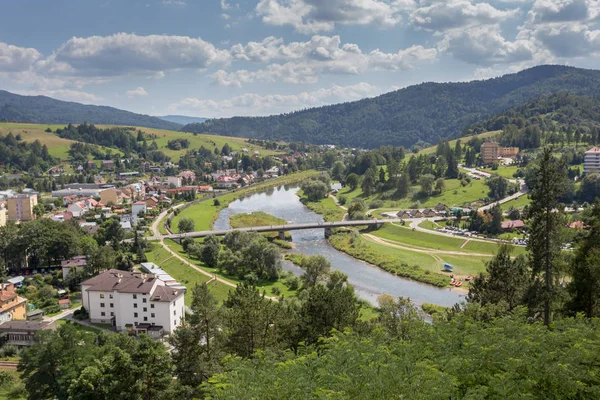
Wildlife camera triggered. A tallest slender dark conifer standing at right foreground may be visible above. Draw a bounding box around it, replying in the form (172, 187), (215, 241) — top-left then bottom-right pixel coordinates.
(527, 147), (566, 325)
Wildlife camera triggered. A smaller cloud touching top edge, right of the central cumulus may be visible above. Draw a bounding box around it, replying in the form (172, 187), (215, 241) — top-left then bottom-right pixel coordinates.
(410, 0), (519, 32)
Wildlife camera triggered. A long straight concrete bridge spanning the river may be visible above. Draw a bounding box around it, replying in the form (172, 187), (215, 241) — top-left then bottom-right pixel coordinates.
(157, 219), (402, 240)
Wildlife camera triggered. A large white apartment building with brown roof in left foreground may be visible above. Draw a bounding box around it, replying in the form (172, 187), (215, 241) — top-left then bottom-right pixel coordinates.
(81, 269), (185, 337)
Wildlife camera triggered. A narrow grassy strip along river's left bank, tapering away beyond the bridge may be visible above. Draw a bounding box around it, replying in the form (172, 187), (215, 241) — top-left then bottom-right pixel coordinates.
(171, 171), (318, 233)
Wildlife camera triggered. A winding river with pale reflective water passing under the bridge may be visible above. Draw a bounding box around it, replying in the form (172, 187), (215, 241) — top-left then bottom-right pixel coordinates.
(214, 186), (464, 307)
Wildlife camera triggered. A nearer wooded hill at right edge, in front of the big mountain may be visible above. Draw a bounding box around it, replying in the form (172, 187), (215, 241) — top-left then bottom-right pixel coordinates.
(467, 93), (600, 149)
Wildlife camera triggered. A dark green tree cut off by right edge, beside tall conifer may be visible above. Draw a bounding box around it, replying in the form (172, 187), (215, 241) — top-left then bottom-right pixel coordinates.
(567, 199), (600, 318)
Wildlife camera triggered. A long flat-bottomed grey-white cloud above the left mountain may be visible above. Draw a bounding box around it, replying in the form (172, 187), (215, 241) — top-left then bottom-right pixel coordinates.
(50, 33), (230, 76)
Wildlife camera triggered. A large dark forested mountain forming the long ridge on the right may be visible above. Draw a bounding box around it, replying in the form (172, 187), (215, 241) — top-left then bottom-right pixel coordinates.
(182, 65), (600, 148)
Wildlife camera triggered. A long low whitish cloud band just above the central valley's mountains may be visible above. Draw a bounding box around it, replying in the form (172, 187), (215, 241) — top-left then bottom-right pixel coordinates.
(169, 82), (377, 117)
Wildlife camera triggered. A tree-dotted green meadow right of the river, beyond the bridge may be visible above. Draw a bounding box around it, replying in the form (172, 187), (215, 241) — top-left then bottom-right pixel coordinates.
(340, 179), (489, 210)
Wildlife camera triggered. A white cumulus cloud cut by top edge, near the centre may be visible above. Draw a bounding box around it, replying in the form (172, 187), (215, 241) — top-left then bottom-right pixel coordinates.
(256, 0), (415, 33)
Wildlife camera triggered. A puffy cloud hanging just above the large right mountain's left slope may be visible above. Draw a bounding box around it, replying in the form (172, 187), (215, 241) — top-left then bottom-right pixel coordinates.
(438, 25), (535, 66)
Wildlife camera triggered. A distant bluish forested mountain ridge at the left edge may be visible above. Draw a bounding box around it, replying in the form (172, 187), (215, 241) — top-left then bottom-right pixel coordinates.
(0, 90), (181, 130)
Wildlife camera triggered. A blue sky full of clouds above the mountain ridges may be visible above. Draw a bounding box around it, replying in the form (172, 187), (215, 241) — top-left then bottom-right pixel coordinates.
(0, 0), (600, 117)
